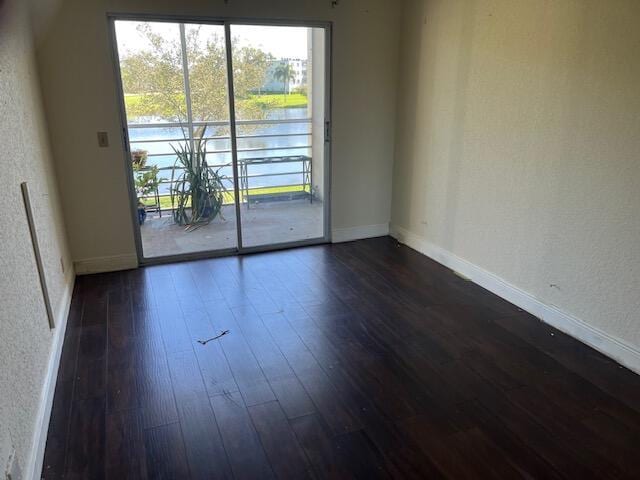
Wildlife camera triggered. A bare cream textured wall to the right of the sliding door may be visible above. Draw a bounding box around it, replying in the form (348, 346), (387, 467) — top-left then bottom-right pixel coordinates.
(392, 0), (640, 346)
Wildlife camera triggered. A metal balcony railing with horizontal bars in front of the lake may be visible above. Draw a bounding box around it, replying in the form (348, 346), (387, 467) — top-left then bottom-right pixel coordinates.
(128, 118), (313, 216)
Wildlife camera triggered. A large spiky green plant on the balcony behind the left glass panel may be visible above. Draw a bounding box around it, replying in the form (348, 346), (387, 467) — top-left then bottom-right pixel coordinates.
(170, 131), (227, 230)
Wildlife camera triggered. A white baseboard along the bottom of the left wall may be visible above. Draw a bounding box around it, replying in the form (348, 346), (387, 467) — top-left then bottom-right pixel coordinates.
(24, 278), (75, 480)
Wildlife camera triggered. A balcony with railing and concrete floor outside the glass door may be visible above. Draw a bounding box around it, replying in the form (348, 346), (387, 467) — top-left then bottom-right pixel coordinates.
(133, 118), (324, 258)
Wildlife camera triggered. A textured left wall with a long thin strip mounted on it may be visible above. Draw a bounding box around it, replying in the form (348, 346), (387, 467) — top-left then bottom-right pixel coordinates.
(0, 0), (73, 475)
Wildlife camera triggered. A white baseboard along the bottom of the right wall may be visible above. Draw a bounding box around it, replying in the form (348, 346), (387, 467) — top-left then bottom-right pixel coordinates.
(390, 224), (640, 373)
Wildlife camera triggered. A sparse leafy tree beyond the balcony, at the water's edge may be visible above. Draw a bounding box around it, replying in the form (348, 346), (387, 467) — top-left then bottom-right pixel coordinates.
(121, 23), (273, 130)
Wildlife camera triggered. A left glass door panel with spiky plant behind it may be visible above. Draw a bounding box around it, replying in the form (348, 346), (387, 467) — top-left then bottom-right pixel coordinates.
(115, 20), (238, 258)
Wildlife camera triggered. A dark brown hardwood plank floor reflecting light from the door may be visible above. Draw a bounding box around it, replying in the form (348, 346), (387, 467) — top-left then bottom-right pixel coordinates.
(42, 237), (640, 479)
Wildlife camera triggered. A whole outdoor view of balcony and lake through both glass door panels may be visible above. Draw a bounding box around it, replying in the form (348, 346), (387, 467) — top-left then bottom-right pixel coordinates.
(114, 18), (329, 261)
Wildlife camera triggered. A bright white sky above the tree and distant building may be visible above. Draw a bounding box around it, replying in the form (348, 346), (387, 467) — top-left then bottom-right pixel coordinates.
(116, 20), (307, 58)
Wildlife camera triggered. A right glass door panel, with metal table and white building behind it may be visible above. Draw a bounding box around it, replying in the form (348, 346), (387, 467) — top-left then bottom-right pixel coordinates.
(230, 24), (326, 248)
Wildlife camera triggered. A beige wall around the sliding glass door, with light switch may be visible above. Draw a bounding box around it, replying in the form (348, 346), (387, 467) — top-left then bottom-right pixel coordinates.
(33, 0), (400, 260)
